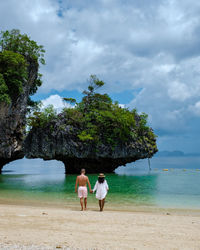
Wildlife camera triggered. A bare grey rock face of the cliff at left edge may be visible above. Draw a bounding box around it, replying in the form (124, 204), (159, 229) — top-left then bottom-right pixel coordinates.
(0, 61), (39, 172)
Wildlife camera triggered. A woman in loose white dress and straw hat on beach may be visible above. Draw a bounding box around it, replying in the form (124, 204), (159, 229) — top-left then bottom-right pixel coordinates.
(93, 173), (109, 212)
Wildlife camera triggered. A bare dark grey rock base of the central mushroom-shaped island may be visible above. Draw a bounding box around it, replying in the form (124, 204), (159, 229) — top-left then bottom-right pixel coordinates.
(24, 114), (157, 174)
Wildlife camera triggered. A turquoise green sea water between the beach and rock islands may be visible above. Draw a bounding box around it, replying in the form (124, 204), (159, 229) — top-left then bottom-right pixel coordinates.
(0, 157), (200, 209)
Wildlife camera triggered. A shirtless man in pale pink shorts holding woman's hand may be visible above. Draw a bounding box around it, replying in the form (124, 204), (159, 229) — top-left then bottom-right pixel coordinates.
(75, 169), (92, 211)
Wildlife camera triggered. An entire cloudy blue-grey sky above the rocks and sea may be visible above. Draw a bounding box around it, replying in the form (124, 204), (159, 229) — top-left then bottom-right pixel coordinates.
(0, 0), (200, 152)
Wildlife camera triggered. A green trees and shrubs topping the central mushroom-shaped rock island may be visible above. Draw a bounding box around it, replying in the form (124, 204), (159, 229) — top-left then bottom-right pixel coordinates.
(29, 75), (156, 147)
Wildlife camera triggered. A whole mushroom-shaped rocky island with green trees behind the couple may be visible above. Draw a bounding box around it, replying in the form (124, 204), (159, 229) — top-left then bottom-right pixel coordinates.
(24, 76), (157, 174)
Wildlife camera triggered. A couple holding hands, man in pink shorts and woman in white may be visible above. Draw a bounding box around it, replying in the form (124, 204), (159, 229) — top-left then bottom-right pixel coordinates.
(75, 169), (109, 212)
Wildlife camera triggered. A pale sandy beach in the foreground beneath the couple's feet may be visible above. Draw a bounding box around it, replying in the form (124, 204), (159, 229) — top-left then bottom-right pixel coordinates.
(0, 204), (200, 250)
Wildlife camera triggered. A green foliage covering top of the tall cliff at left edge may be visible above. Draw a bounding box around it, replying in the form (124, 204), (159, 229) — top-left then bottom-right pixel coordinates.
(0, 29), (45, 106)
